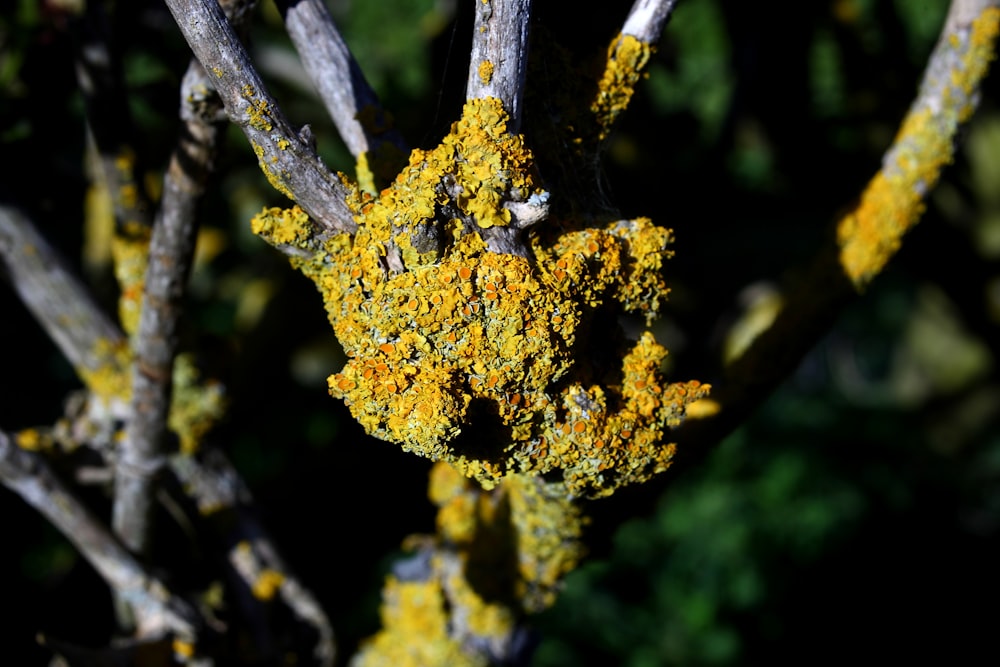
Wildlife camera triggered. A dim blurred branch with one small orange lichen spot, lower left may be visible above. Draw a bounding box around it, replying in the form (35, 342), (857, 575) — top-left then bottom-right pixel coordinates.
(170, 449), (336, 665)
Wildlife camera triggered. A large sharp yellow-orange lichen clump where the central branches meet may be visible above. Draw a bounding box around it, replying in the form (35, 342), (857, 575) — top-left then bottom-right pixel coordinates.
(253, 98), (707, 496)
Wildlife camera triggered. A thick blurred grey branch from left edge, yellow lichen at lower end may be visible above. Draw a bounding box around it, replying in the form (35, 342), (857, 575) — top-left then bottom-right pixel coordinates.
(0, 205), (126, 395)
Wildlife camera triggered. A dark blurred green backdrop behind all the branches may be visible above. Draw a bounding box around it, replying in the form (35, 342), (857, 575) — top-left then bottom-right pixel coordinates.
(0, 0), (1000, 667)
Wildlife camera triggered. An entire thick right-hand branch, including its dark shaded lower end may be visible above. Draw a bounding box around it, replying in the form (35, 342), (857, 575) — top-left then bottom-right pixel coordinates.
(675, 0), (1000, 465)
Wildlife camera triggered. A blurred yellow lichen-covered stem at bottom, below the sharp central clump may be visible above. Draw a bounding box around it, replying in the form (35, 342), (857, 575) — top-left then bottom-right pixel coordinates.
(351, 463), (585, 667)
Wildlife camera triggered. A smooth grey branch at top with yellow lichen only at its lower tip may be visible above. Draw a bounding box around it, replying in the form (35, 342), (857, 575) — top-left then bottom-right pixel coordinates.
(276, 0), (409, 193)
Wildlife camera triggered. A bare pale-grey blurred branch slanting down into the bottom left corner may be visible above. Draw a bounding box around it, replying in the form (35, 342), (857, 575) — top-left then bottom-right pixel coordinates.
(0, 431), (202, 641)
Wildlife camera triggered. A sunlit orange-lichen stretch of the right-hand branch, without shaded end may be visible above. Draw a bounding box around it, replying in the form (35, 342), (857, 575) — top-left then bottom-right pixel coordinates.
(837, 8), (1000, 289)
